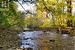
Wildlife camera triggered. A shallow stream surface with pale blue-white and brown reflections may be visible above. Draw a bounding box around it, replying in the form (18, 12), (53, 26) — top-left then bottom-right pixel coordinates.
(19, 31), (75, 50)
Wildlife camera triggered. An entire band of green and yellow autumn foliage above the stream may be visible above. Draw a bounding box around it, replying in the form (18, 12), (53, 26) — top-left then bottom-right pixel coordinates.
(0, 0), (75, 28)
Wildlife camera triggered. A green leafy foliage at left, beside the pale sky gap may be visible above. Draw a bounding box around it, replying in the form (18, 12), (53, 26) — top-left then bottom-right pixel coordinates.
(0, 2), (19, 28)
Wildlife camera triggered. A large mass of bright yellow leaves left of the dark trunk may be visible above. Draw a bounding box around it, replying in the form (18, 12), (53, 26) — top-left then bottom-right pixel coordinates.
(28, 0), (73, 27)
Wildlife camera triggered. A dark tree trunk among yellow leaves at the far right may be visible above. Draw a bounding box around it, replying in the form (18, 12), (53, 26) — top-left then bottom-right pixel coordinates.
(67, 0), (72, 27)
